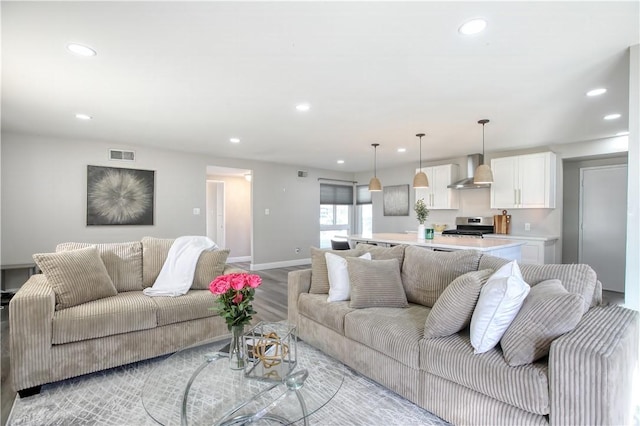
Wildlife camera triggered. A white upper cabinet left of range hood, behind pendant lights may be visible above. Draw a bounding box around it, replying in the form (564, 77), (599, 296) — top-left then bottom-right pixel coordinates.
(416, 164), (459, 210)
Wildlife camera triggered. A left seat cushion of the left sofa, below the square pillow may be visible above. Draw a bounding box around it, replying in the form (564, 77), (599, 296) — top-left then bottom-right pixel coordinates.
(52, 291), (157, 345)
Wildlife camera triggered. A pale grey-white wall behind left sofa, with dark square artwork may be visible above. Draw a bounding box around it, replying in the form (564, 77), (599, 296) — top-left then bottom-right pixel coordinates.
(0, 133), (353, 280)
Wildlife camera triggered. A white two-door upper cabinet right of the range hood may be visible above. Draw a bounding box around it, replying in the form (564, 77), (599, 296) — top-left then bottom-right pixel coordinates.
(491, 152), (556, 209)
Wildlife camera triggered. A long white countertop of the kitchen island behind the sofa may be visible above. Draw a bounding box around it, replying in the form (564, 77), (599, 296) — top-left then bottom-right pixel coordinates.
(349, 233), (525, 251)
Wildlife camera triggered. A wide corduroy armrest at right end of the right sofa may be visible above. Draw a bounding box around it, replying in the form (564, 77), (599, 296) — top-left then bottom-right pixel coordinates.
(549, 306), (639, 425)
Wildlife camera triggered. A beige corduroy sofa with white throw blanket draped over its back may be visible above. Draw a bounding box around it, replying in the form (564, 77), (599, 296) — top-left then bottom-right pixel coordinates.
(9, 237), (240, 397)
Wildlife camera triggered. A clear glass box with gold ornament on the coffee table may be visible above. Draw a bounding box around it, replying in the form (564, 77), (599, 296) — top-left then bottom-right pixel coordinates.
(244, 322), (297, 381)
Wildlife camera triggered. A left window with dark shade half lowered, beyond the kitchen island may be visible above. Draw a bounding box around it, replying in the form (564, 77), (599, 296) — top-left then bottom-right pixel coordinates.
(320, 184), (353, 248)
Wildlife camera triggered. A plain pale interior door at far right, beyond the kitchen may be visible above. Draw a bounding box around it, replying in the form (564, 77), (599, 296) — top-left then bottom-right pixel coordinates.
(578, 164), (627, 293)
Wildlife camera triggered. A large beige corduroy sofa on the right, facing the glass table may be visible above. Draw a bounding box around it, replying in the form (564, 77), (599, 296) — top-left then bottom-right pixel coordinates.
(288, 245), (639, 425)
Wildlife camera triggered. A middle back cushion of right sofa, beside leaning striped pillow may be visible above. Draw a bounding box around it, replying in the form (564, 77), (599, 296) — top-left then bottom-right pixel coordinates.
(402, 246), (485, 307)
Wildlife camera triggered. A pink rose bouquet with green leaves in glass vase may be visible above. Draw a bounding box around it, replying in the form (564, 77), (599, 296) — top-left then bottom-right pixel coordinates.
(209, 273), (262, 330)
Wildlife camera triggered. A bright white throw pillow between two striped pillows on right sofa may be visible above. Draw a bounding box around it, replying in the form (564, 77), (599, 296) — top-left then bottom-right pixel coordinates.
(471, 260), (531, 354)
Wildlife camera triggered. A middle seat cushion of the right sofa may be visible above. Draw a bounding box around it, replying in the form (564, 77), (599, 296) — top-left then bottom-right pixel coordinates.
(344, 304), (430, 369)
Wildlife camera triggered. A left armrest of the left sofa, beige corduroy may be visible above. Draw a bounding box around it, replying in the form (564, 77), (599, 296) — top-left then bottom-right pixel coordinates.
(9, 274), (56, 391)
